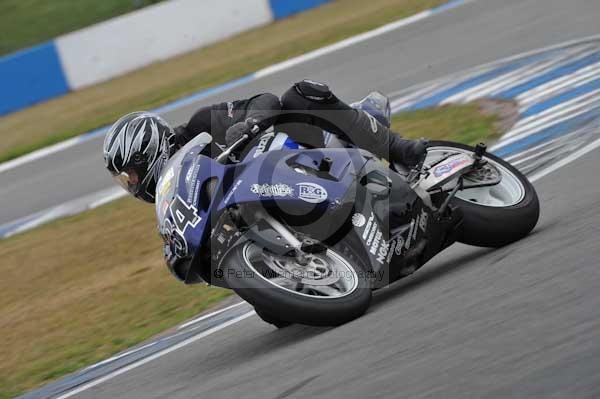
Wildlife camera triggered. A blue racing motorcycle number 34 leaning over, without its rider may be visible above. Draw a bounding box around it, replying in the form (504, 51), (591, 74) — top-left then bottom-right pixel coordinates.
(156, 100), (539, 327)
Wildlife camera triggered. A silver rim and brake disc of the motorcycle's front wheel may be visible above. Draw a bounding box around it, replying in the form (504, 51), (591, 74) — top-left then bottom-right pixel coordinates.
(243, 243), (358, 299)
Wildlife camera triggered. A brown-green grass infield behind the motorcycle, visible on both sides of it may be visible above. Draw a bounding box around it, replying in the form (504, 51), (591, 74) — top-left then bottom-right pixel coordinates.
(0, 104), (500, 399)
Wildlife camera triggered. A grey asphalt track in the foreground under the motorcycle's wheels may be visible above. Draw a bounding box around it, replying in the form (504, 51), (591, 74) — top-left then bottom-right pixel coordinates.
(61, 152), (600, 399)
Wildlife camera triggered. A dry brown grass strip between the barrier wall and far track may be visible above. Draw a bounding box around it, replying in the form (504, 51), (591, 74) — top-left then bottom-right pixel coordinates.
(0, 0), (446, 162)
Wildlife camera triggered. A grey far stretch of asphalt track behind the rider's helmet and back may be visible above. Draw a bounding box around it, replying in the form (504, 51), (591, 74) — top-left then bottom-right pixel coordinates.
(0, 0), (600, 225)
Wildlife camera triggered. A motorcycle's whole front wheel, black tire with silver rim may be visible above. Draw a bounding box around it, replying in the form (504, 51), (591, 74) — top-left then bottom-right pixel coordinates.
(223, 241), (372, 326)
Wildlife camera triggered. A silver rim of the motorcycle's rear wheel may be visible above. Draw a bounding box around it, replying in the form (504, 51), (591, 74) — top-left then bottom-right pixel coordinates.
(425, 146), (525, 208)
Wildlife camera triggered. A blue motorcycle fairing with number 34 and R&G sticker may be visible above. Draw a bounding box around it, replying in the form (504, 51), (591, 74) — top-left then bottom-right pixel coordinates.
(156, 130), (418, 283)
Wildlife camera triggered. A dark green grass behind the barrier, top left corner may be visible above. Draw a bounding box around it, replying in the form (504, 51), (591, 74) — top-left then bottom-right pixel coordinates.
(0, 0), (162, 56)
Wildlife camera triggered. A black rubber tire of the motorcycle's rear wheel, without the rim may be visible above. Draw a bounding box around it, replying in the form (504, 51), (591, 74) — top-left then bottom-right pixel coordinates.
(429, 141), (540, 248)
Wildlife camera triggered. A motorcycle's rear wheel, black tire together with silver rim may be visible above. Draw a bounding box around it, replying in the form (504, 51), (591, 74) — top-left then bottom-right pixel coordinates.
(428, 141), (540, 248)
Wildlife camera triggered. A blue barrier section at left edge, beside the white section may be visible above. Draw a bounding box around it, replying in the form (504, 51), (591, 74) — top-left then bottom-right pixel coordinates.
(0, 42), (69, 115)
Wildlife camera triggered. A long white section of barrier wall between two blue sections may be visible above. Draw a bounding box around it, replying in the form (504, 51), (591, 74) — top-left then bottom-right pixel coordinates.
(56, 0), (273, 90)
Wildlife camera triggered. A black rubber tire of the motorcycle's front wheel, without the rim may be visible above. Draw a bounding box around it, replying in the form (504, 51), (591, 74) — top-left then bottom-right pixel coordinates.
(223, 241), (372, 326)
